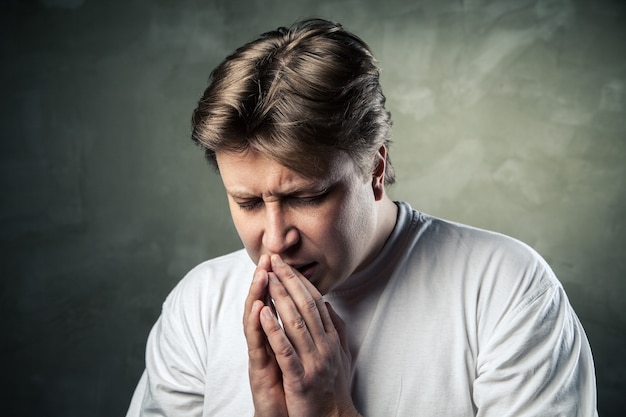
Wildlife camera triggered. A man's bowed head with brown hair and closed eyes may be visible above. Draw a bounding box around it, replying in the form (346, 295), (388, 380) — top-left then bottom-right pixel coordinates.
(188, 20), (396, 293)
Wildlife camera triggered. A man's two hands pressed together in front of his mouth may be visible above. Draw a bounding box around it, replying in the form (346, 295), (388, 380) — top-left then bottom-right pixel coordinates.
(243, 255), (359, 417)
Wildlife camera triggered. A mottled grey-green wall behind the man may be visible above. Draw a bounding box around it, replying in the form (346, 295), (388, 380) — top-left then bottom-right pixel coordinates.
(0, 0), (626, 417)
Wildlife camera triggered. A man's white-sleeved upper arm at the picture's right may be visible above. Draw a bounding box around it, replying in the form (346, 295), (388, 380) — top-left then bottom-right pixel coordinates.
(473, 283), (597, 417)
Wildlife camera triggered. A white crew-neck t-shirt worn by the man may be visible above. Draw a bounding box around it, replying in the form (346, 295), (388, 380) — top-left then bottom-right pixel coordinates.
(127, 202), (597, 417)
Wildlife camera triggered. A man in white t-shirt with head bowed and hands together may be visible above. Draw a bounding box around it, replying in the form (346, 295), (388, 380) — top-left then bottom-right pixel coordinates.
(128, 20), (596, 417)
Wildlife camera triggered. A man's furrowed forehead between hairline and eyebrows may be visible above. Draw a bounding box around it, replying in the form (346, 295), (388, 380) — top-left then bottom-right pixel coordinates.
(216, 150), (356, 194)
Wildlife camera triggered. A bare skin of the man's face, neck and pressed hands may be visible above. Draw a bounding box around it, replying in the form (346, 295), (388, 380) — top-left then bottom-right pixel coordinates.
(217, 147), (397, 417)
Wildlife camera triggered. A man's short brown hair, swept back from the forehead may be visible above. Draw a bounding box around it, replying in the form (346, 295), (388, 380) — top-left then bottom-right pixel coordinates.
(192, 19), (395, 185)
